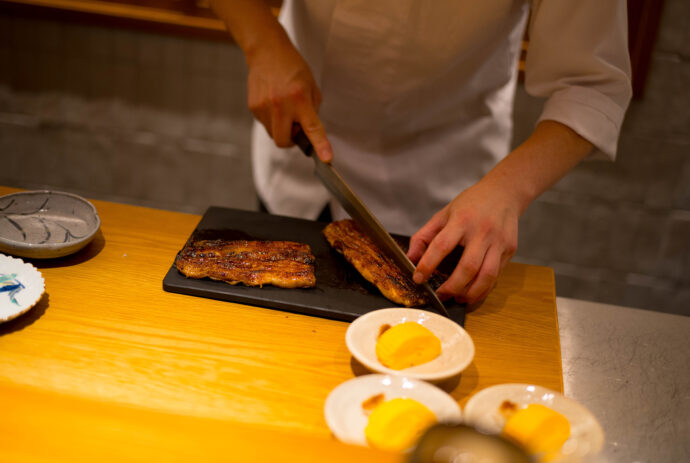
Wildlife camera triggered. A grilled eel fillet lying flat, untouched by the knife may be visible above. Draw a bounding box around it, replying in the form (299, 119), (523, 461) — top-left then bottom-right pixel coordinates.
(175, 240), (316, 288)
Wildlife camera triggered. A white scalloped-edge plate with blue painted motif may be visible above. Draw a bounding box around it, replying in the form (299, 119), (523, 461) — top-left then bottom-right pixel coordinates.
(0, 254), (45, 323)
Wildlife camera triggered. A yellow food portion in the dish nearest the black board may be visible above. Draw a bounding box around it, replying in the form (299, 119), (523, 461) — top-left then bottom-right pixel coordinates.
(376, 322), (441, 370)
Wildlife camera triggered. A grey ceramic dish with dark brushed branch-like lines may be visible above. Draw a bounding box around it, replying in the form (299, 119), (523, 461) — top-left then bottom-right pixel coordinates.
(0, 190), (101, 259)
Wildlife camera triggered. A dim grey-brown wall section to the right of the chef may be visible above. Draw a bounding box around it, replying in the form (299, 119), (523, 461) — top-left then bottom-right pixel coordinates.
(508, 0), (690, 315)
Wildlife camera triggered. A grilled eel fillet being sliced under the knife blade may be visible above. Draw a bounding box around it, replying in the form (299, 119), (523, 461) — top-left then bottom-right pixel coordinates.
(323, 219), (440, 307)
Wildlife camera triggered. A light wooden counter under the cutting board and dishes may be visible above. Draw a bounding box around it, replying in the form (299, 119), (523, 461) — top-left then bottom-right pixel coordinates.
(0, 187), (563, 461)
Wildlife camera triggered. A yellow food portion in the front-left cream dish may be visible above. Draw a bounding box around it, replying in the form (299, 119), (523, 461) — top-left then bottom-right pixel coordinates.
(364, 398), (437, 452)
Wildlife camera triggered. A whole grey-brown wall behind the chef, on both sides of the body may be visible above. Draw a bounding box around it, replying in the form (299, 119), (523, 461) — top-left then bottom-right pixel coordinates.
(0, 0), (690, 315)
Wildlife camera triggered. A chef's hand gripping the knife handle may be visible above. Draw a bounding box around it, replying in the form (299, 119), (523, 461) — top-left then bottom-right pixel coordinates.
(247, 38), (333, 162)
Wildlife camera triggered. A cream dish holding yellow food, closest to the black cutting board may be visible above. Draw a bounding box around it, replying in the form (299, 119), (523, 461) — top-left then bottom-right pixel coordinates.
(345, 308), (474, 382)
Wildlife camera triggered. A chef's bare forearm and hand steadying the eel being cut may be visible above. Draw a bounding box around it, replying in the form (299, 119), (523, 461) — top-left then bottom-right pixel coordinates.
(407, 120), (594, 303)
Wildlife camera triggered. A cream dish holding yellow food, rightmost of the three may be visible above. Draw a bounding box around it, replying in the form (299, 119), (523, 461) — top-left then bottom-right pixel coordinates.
(465, 384), (604, 461)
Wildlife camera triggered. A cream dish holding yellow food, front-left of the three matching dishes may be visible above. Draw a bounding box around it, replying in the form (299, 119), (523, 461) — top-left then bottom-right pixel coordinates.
(324, 374), (462, 446)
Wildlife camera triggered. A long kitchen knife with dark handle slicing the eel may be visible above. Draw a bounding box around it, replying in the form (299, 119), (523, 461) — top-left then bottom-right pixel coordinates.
(292, 128), (451, 318)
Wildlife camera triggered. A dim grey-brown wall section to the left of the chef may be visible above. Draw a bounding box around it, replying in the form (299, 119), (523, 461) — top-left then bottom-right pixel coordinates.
(0, 15), (256, 213)
